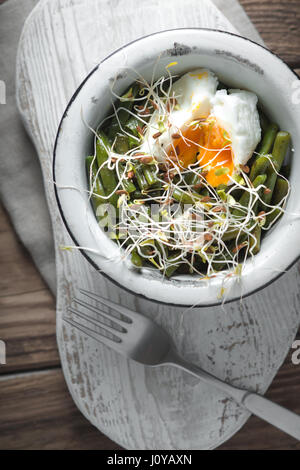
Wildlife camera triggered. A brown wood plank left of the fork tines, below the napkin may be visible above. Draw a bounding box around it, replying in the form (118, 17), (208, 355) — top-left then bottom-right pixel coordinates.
(0, 206), (59, 374)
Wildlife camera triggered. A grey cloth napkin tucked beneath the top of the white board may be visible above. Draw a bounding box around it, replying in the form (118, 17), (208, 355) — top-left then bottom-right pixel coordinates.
(0, 0), (262, 294)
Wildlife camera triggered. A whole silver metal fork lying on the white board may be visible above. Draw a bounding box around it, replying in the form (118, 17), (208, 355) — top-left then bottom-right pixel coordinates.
(63, 289), (300, 440)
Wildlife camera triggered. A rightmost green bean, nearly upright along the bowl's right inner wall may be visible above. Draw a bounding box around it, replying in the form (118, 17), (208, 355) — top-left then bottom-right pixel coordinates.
(262, 131), (291, 210)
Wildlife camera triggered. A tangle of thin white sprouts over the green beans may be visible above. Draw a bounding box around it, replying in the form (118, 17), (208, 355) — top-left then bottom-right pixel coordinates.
(86, 68), (290, 279)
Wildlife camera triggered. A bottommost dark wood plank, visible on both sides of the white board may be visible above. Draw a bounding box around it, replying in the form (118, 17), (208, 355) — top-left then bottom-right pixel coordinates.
(0, 357), (300, 450)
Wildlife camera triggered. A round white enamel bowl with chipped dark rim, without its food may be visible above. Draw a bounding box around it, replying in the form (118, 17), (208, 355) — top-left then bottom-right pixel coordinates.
(53, 29), (300, 306)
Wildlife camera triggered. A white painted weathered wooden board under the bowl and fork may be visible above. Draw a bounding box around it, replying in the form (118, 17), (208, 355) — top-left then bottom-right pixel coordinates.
(17, 0), (300, 449)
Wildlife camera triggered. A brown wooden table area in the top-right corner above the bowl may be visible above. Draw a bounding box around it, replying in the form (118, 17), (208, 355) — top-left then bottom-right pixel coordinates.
(240, 0), (300, 68)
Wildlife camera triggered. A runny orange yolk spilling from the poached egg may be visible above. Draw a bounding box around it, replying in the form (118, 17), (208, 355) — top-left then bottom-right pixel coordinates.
(168, 118), (234, 187)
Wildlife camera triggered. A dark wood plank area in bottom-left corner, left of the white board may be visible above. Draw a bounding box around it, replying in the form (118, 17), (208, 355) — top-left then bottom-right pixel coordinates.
(0, 369), (118, 450)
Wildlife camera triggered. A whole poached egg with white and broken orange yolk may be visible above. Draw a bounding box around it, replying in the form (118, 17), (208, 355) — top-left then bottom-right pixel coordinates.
(140, 68), (261, 187)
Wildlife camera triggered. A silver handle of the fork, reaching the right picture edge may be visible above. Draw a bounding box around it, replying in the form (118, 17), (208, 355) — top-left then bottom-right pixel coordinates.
(168, 351), (300, 441)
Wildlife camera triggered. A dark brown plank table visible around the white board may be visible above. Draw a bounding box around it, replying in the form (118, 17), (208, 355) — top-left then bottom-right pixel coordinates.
(0, 0), (300, 450)
